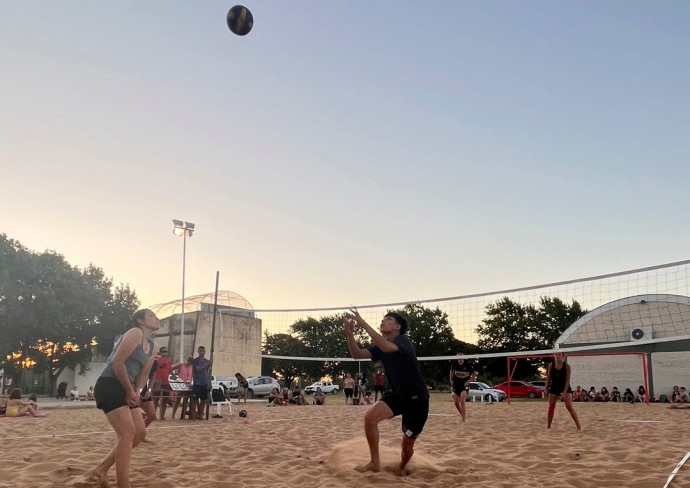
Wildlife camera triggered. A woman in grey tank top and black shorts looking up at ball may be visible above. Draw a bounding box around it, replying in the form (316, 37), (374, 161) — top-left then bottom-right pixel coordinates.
(92, 309), (161, 488)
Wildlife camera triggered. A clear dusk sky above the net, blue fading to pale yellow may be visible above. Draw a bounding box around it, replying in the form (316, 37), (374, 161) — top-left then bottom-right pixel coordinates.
(0, 0), (690, 309)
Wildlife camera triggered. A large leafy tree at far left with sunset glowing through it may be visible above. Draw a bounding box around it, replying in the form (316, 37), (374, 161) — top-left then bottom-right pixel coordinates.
(0, 234), (138, 392)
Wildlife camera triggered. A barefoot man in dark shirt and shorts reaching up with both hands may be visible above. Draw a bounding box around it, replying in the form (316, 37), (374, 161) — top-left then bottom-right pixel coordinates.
(343, 308), (429, 475)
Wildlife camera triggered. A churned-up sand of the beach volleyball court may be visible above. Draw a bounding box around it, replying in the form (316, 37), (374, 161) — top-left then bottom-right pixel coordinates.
(0, 395), (690, 488)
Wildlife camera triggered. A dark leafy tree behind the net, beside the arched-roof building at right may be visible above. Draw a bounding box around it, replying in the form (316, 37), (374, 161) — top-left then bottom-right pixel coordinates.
(476, 297), (587, 378)
